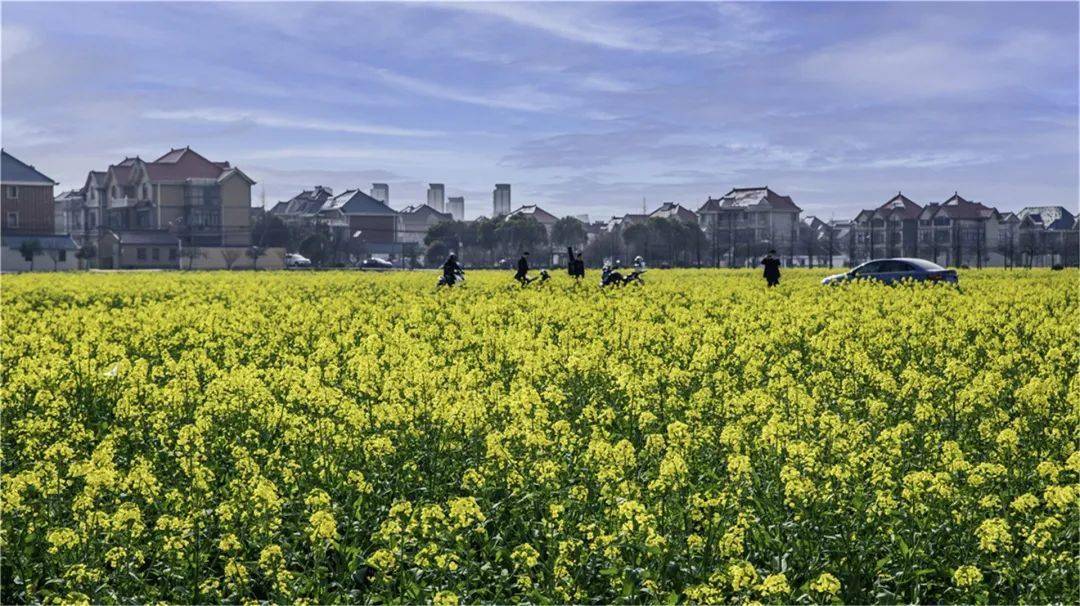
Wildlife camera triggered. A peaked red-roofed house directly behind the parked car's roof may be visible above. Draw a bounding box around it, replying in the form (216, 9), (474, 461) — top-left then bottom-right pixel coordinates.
(849, 192), (922, 262)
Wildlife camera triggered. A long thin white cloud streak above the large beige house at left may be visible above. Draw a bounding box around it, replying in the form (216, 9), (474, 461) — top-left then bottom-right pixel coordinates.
(143, 107), (446, 137)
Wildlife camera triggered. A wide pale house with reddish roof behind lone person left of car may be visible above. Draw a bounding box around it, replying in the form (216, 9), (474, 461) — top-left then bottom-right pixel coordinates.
(698, 187), (802, 267)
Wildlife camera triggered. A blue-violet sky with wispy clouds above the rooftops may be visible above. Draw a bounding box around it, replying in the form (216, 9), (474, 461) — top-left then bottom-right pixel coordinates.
(0, 2), (1080, 218)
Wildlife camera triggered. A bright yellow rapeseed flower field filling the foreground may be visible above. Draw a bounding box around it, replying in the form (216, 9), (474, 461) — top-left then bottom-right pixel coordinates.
(0, 270), (1080, 604)
